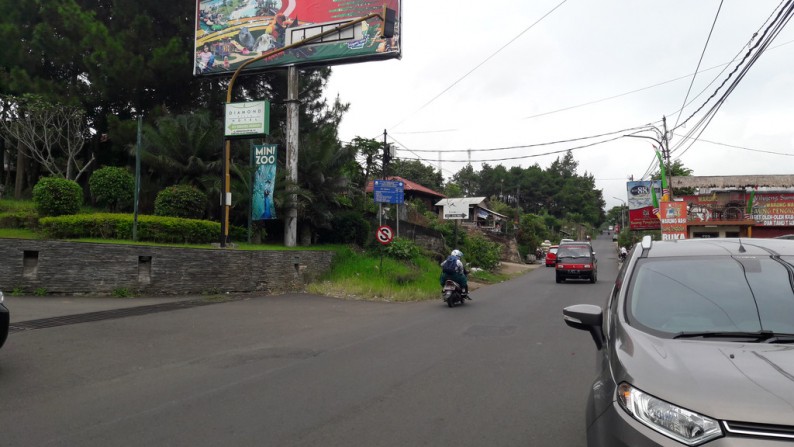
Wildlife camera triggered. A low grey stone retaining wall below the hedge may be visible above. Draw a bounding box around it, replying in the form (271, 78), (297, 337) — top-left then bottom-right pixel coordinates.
(0, 239), (334, 295)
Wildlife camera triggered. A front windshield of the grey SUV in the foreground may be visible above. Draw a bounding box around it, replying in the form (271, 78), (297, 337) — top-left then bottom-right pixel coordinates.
(626, 256), (794, 334)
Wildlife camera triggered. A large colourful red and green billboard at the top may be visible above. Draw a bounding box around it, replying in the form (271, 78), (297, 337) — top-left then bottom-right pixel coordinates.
(193, 0), (402, 76)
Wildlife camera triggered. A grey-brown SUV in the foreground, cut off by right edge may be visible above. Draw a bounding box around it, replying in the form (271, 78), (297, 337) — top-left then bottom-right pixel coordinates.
(561, 236), (794, 447)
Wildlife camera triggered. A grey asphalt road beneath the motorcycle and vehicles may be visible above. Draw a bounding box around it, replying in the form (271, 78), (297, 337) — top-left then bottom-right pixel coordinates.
(0, 236), (617, 447)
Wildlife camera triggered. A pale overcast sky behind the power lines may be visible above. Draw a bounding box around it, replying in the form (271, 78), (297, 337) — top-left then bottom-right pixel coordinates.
(327, 0), (794, 209)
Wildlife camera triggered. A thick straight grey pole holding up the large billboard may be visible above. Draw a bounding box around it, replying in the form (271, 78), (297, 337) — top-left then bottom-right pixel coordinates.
(284, 65), (300, 247)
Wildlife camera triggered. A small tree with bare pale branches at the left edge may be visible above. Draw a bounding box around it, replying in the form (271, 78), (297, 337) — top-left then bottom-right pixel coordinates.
(0, 95), (95, 181)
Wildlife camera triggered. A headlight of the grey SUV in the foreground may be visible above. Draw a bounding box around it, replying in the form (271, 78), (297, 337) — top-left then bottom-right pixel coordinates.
(618, 383), (722, 446)
